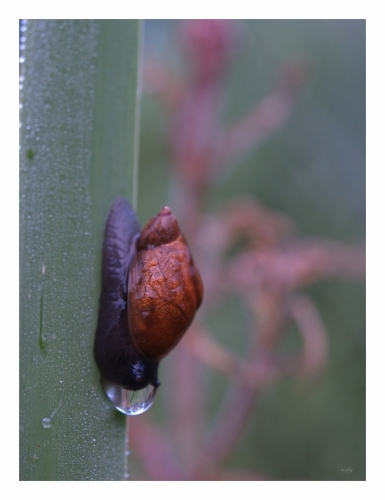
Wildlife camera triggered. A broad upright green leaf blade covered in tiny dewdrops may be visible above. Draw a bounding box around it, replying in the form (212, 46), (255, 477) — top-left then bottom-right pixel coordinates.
(20, 20), (140, 480)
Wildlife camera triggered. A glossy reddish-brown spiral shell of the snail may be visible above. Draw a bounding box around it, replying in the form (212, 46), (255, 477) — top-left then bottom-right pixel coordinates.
(128, 207), (203, 362)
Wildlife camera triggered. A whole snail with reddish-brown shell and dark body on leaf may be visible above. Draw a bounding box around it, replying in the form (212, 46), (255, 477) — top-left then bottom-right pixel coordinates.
(94, 198), (203, 391)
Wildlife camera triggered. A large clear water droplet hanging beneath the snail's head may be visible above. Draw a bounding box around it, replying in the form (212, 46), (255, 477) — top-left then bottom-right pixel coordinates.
(103, 381), (157, 415)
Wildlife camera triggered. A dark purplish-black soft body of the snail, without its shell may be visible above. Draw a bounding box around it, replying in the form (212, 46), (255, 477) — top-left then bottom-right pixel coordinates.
(94, 198), (160, 390)
